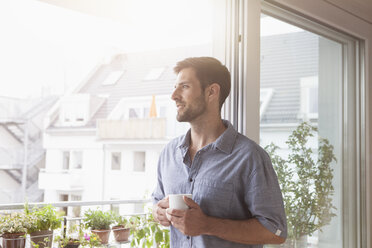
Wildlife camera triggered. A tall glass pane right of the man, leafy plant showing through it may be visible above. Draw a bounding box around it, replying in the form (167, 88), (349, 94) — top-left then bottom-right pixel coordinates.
(260, 15), (343, 248)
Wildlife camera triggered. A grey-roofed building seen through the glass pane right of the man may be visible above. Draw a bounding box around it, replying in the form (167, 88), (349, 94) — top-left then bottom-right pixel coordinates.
(260, 31), (320, 152)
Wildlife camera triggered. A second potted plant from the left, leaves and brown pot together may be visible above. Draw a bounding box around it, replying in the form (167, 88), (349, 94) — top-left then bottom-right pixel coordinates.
(25, 204), (62, 248)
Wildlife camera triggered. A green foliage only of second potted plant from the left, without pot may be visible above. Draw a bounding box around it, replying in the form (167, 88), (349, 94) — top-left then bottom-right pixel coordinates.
(25, 204), (63, 233)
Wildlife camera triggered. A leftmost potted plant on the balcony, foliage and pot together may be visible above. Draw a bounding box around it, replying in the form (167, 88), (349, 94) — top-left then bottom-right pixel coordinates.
(0, 213), (30, 248)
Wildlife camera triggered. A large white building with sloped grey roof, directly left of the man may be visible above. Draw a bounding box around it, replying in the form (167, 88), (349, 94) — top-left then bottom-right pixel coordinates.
(39, 45), (211, 215)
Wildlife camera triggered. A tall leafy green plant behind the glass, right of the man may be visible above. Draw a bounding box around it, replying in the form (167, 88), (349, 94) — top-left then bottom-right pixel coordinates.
(265, 122), (336, 247)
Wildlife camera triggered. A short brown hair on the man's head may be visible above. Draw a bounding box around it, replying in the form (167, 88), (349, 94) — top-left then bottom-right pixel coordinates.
(173, 57), (231, 110)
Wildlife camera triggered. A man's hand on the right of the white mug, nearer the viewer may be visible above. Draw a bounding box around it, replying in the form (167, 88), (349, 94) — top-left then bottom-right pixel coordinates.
(167, 196), (208, 236)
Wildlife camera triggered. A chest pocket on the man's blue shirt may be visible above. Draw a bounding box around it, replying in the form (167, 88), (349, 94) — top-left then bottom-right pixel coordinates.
(192, 179), (234, 218)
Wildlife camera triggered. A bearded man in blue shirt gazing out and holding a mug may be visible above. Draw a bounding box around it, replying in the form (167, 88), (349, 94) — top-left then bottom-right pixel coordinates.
(152, 57), (287, 248)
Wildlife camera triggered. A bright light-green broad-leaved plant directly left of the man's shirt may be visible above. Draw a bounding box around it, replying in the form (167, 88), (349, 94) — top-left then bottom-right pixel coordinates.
(129, 210), (170, 248)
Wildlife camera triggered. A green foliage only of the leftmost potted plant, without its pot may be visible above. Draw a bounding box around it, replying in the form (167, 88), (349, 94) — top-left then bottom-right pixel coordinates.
(0, 213), (31, 234)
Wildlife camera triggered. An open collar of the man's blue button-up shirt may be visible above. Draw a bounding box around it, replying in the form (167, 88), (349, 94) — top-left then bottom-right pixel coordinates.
(178, 120), (238, 155)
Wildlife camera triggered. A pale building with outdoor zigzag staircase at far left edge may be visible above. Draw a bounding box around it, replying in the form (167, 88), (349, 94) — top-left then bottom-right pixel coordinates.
(0, 97), (57, 203)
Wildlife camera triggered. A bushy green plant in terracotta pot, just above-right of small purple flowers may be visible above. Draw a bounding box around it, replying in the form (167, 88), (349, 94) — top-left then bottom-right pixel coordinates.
(84, 209), (114, 244)
